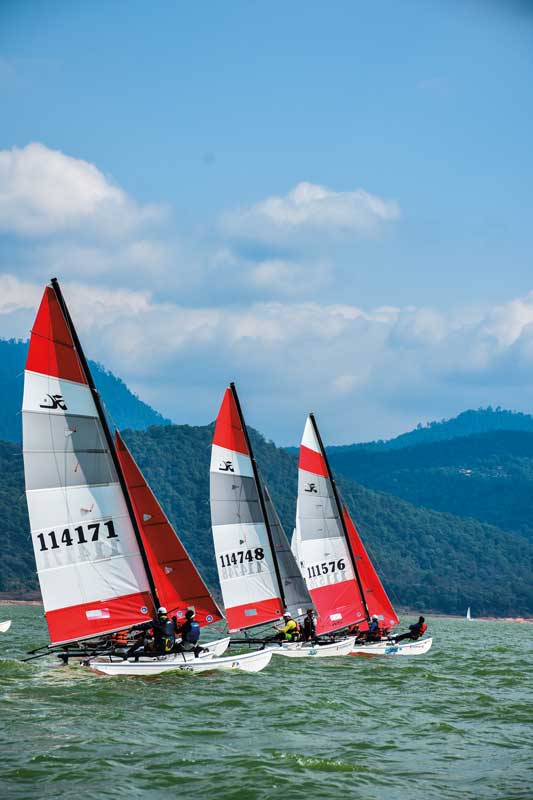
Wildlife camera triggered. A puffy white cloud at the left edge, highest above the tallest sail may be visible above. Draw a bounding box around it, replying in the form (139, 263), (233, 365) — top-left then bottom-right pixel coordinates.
(0, 143), (162, 238)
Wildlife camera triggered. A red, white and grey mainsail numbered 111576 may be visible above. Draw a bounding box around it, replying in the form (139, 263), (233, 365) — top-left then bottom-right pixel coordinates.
(293, 416), (367, 633)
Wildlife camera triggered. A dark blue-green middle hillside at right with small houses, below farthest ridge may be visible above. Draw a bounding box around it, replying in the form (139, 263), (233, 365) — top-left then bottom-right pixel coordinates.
(329, 431), (533, 541)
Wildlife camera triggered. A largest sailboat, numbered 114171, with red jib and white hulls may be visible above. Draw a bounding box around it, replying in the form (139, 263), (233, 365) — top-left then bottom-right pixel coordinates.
(22, 279), (268, 674)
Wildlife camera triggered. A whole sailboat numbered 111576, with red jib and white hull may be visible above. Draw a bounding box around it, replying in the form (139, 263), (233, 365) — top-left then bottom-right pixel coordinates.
(292, 414), (431, 655)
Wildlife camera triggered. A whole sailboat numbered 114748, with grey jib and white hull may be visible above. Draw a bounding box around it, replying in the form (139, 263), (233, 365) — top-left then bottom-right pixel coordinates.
(210, 383), (354, 658)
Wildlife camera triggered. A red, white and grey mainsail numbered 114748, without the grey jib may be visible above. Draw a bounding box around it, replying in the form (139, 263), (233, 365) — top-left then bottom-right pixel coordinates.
(211, 389), (283, 631)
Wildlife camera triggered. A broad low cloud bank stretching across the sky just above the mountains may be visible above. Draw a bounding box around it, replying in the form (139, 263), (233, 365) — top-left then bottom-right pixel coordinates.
(0, 276), (533, 443)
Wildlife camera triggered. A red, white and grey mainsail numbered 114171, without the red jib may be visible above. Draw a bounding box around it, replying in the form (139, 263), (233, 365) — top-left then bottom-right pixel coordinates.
(22, 287), (154, 643)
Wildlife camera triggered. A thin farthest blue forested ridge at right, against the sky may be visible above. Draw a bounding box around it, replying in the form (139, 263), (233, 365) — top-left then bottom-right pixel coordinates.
(328, 406), (533, 453)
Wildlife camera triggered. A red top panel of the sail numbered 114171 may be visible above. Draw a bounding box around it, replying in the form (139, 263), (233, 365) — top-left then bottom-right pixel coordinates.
(26, 286), (87, 384)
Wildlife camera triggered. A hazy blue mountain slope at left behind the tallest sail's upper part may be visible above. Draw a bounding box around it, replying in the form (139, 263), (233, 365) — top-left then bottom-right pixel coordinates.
(0, 339), (170, 442)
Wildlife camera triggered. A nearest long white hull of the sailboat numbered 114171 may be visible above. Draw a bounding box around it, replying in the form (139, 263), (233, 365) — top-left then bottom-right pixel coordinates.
(87, 650), (272, 676)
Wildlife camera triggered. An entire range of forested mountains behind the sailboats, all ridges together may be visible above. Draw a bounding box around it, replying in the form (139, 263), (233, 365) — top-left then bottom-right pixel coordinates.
(0, 342), (533, 616)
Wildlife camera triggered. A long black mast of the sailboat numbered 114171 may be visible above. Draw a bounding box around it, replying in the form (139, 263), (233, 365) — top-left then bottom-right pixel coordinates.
(52, 278), (160, 609)
